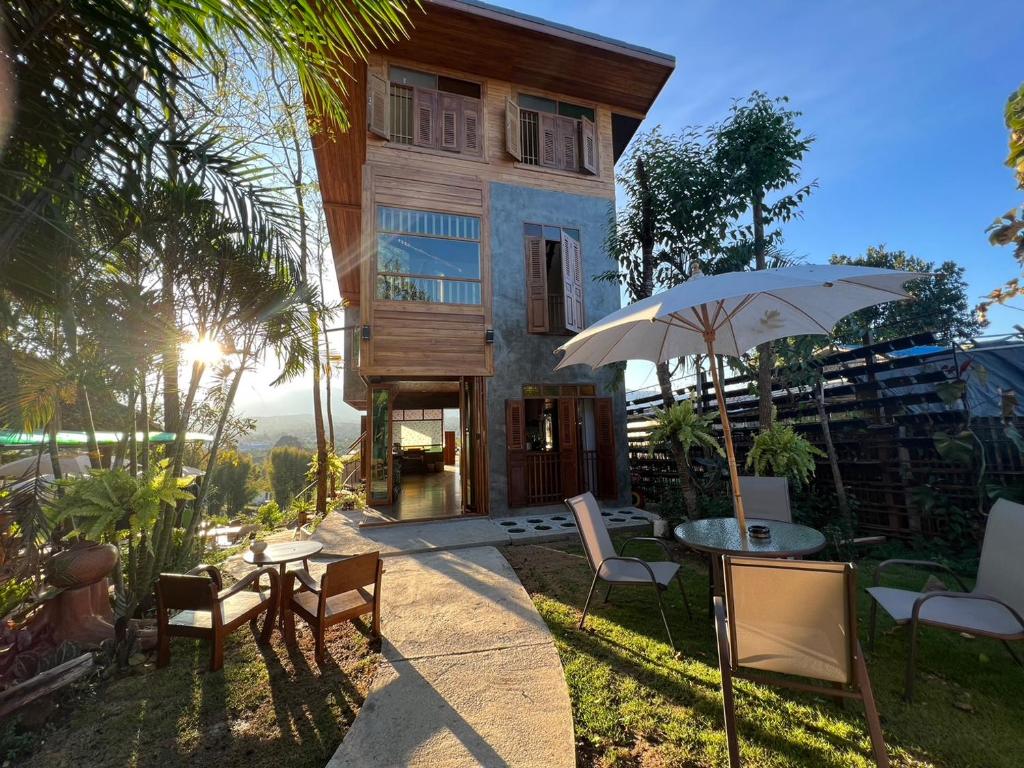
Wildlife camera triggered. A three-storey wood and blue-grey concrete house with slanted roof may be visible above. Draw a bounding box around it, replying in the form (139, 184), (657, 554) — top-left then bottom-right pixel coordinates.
(313, 0), (675, 519)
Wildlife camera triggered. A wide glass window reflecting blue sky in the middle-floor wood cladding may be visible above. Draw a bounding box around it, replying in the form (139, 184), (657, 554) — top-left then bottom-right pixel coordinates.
(377, 206), (480, 304)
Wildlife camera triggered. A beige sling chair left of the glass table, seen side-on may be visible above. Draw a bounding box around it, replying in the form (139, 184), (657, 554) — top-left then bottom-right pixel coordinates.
(565, 492), (692, 650)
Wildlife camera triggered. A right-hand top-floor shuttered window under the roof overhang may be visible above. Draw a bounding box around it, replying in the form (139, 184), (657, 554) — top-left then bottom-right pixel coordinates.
(506, 93), (597, 174)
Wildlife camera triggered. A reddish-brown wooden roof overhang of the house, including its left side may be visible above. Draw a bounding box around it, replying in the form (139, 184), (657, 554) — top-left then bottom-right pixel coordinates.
(313, 0), (676, 304)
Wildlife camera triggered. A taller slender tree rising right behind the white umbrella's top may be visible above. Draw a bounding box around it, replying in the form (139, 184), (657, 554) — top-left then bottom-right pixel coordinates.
(713, 91), (817, 429)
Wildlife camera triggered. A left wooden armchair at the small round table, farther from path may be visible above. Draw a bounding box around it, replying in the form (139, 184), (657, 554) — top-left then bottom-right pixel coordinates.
(157, 565), (280, 672)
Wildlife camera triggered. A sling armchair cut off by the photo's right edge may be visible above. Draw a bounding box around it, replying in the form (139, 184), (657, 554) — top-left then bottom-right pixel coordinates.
(867, 499), (1024, 701)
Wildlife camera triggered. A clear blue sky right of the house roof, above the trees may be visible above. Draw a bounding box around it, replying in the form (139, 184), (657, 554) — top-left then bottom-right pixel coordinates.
(234, 0), (1024, 415)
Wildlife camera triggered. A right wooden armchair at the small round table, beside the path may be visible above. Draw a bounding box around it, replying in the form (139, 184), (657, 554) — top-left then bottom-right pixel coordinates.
(284, 552), (384, 664)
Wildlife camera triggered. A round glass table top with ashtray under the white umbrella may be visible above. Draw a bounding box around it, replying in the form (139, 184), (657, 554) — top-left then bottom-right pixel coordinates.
(674, 517), (825, 557)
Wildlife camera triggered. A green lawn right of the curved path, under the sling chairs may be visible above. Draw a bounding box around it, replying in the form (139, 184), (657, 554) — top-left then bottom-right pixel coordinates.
(504, 536), (1024, 768)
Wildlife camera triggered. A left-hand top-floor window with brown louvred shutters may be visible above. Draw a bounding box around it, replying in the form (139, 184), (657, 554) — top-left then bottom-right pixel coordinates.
(369, 67), (482, 155)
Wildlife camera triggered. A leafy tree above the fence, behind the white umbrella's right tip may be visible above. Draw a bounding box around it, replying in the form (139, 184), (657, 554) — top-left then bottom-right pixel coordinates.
(830, 245), (980, 344)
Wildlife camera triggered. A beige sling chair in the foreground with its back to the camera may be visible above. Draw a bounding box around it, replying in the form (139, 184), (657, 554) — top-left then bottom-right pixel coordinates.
(715, 557), (889, 768)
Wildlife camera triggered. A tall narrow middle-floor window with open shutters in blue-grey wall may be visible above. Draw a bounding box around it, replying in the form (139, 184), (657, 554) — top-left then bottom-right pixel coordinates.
(523, 224), (585, 334)
